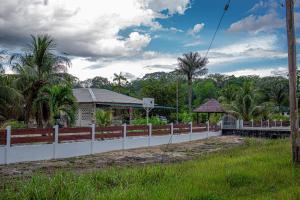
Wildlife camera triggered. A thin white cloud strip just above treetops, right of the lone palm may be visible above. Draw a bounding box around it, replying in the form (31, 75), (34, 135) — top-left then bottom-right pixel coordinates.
(224, 67), (287, 77)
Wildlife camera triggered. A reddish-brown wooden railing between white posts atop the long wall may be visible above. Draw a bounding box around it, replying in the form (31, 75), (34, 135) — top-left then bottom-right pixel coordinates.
(0, 123), (220, 146)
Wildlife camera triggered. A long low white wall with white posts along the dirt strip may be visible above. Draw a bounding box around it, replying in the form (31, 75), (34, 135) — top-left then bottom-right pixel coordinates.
(0, 124), (221, 164)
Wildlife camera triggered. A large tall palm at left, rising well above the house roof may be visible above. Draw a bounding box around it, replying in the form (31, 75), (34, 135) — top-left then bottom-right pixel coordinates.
(10, 35), (70, 127)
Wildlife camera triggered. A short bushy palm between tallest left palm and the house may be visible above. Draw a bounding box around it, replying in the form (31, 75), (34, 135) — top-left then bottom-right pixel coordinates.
(34, 85), (77, 125)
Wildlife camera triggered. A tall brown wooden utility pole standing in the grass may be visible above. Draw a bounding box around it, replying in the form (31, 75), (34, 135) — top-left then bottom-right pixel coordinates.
(286, 0), (300, 164)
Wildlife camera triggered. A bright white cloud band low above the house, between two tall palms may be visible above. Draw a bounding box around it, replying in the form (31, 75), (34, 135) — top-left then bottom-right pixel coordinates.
(69, 52), (177, 80)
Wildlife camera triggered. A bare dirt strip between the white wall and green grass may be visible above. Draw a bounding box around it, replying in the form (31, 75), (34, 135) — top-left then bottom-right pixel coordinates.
(0, 136), (244, 185)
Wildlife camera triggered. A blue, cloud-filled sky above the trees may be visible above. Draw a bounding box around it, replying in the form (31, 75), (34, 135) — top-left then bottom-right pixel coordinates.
(0, 0), (300, 80)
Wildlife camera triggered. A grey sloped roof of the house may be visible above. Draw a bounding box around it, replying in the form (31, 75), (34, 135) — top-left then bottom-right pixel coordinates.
(73, 88), (143, 104)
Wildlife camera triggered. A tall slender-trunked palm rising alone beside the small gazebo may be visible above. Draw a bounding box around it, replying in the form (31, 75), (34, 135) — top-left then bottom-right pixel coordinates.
(177, 52), (208, 113)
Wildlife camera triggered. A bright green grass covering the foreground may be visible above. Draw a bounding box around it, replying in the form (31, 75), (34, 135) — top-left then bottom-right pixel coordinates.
(0, 139), (300, 200)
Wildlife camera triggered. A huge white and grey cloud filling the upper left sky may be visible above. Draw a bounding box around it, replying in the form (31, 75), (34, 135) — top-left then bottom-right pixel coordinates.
(0, 0), (189, 57)
